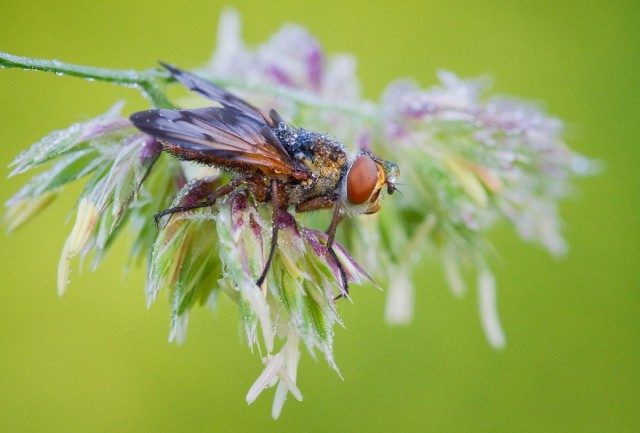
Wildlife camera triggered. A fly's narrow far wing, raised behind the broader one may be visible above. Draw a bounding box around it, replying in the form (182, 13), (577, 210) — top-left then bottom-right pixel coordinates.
(160, 62), (276, 126)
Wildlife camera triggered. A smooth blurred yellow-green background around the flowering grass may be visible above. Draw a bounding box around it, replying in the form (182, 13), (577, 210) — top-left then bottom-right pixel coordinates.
(0, 0), (640, 433)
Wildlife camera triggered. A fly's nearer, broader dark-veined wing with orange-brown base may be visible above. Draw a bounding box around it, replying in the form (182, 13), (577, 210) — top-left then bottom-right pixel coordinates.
(130, 107), (308, 179)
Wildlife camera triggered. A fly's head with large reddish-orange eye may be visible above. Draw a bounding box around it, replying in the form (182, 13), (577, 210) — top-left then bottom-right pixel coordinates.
(342, 151), (400, 214)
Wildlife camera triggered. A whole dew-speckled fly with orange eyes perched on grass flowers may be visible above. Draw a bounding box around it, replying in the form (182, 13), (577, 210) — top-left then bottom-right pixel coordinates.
(130, 63), (400, 297)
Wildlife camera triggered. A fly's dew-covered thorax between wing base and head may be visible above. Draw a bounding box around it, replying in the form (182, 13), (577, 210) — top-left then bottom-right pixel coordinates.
(273, 123), (349, 205)
